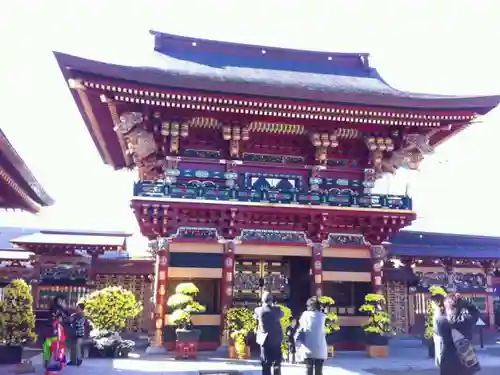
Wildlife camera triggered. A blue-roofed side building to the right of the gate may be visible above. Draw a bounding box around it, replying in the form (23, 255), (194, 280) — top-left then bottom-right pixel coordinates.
(384, 231), (500, 334)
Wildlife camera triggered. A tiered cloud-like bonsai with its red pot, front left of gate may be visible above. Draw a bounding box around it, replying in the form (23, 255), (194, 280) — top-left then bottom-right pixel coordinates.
(167, 283), (206, 358)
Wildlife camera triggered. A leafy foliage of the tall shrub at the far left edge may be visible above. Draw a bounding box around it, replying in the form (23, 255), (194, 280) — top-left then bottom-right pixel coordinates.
(0, 279), (37, 345)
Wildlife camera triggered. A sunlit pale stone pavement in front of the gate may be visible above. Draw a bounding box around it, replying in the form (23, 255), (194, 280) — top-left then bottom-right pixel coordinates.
(6, 345), (500, 375)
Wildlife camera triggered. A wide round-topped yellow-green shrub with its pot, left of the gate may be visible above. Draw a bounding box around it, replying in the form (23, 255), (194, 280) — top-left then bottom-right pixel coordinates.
(80, 287), (142, 358)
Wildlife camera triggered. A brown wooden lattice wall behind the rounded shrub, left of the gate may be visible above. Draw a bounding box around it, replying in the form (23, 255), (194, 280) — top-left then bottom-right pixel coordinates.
(96, 274), (151, 332)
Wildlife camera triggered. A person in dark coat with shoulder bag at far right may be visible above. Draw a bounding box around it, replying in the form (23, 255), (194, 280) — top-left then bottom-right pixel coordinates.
(436, 295), (480, 375)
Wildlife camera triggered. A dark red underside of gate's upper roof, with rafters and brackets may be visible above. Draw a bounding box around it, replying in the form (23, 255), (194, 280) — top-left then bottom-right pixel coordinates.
(69, 76), (484, 175)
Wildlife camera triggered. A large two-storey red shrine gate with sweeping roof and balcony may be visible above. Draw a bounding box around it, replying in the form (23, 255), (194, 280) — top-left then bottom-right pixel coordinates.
(55, 32), (500, 349)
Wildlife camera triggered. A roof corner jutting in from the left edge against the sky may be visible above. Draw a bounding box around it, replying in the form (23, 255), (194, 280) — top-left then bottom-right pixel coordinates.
(0, 129), (54, 213)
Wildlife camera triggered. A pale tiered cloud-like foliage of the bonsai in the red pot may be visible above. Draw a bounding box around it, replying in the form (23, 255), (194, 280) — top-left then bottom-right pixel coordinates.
(167, 283), (206, 329)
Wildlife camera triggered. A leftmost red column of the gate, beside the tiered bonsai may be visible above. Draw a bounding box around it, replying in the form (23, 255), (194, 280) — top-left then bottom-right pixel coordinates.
(153, 238), (168, 348)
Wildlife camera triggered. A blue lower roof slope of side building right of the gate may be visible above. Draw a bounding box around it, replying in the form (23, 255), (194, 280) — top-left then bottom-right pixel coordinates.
(388, 244), (500, 259)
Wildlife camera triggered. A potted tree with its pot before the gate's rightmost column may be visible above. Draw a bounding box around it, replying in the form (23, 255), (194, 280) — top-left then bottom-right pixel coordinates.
(359, 293), (394, 358)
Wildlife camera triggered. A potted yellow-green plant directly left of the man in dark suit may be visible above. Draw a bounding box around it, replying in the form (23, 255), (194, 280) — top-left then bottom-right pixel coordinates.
(226, 307), (257, 359)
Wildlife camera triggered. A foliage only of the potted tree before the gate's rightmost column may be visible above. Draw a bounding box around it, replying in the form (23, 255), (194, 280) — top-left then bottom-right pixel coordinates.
(359, 293), (394, 336)
